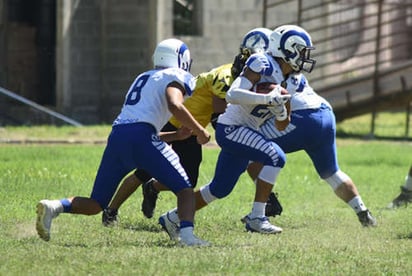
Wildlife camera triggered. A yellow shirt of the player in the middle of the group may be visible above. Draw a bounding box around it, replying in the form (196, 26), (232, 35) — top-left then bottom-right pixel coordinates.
(169, 63), (233, 128)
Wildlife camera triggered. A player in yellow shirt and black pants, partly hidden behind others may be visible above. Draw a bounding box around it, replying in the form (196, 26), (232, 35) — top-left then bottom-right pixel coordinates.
(102, 28), (282, 226)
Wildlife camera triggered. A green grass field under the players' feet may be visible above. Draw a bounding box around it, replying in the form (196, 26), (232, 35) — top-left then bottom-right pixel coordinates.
(0, 117), (412, 275)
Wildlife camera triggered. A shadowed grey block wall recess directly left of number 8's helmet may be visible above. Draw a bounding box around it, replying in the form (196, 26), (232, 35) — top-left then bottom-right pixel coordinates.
(101, 0), (152, 122)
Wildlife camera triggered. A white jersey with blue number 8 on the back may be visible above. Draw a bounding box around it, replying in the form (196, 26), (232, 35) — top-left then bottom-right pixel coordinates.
(113, 68), (196, 132)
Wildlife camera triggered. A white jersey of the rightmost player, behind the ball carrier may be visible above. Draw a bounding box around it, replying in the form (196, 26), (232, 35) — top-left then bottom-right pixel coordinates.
(285, 73), (332, 111)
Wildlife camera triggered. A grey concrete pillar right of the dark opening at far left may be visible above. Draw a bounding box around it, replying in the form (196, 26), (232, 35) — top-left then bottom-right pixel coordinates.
(56, 0), (101, 122)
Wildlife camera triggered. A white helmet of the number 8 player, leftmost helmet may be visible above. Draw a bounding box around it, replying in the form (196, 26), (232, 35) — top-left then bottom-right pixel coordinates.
(153, 38), (192, 71)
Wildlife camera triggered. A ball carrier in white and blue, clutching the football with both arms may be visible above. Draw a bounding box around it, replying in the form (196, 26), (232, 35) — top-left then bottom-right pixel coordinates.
(159, 24), (300, 239)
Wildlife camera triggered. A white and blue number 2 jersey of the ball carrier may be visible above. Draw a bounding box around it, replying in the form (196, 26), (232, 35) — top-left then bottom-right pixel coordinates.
(218, 53), (284, 130)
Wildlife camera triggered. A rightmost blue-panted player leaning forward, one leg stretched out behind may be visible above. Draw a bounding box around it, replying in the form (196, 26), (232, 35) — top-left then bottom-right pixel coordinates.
(249, 25), (376, 226)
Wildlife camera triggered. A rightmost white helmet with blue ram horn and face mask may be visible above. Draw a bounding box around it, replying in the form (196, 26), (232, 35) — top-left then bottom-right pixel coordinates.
(268, 25), (316, 73)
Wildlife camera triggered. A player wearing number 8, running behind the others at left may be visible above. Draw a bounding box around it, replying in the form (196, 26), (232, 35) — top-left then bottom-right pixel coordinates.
(36, 38), (210, 246)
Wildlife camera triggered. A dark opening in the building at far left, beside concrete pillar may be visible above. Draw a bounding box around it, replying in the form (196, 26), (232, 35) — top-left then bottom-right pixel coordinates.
(7, 0), (56, 106)
